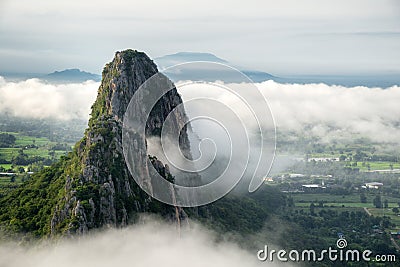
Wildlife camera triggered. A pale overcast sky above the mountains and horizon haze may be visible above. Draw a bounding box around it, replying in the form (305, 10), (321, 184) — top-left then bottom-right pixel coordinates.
(0, 0), (400, 75)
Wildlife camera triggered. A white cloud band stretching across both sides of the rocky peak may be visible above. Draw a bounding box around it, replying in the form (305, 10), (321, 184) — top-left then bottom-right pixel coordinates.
(0, 77), (400, 143)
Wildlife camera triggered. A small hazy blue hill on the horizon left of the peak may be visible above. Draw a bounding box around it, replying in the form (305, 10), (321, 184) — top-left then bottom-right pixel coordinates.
(43, 69), (101, 82)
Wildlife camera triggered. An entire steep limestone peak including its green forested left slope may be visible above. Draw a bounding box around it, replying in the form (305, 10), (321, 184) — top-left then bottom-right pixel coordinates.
(0, 49), (189, 236)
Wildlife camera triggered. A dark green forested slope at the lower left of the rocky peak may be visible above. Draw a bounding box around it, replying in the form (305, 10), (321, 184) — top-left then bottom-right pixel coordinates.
(0, 155), (71, 237)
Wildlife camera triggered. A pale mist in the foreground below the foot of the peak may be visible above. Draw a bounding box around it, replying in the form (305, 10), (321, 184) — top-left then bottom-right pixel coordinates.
(0, 221), (275, 267)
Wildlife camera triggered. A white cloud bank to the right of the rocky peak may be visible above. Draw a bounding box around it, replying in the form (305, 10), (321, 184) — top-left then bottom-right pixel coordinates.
(180, 81), (400, 146)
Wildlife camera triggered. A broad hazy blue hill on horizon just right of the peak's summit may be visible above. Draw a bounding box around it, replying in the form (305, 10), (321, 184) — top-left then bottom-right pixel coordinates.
(154, 52), (279, 82)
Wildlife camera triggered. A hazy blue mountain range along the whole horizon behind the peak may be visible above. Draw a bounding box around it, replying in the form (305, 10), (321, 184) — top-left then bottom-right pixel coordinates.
(0, 52), (400, 88)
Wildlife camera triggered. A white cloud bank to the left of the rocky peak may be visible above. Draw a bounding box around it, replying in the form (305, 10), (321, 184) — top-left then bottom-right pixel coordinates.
(0, 76), (99, 120)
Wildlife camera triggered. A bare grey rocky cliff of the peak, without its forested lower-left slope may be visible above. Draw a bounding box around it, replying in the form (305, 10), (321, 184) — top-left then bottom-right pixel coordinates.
(50, 50), (189, 234)
